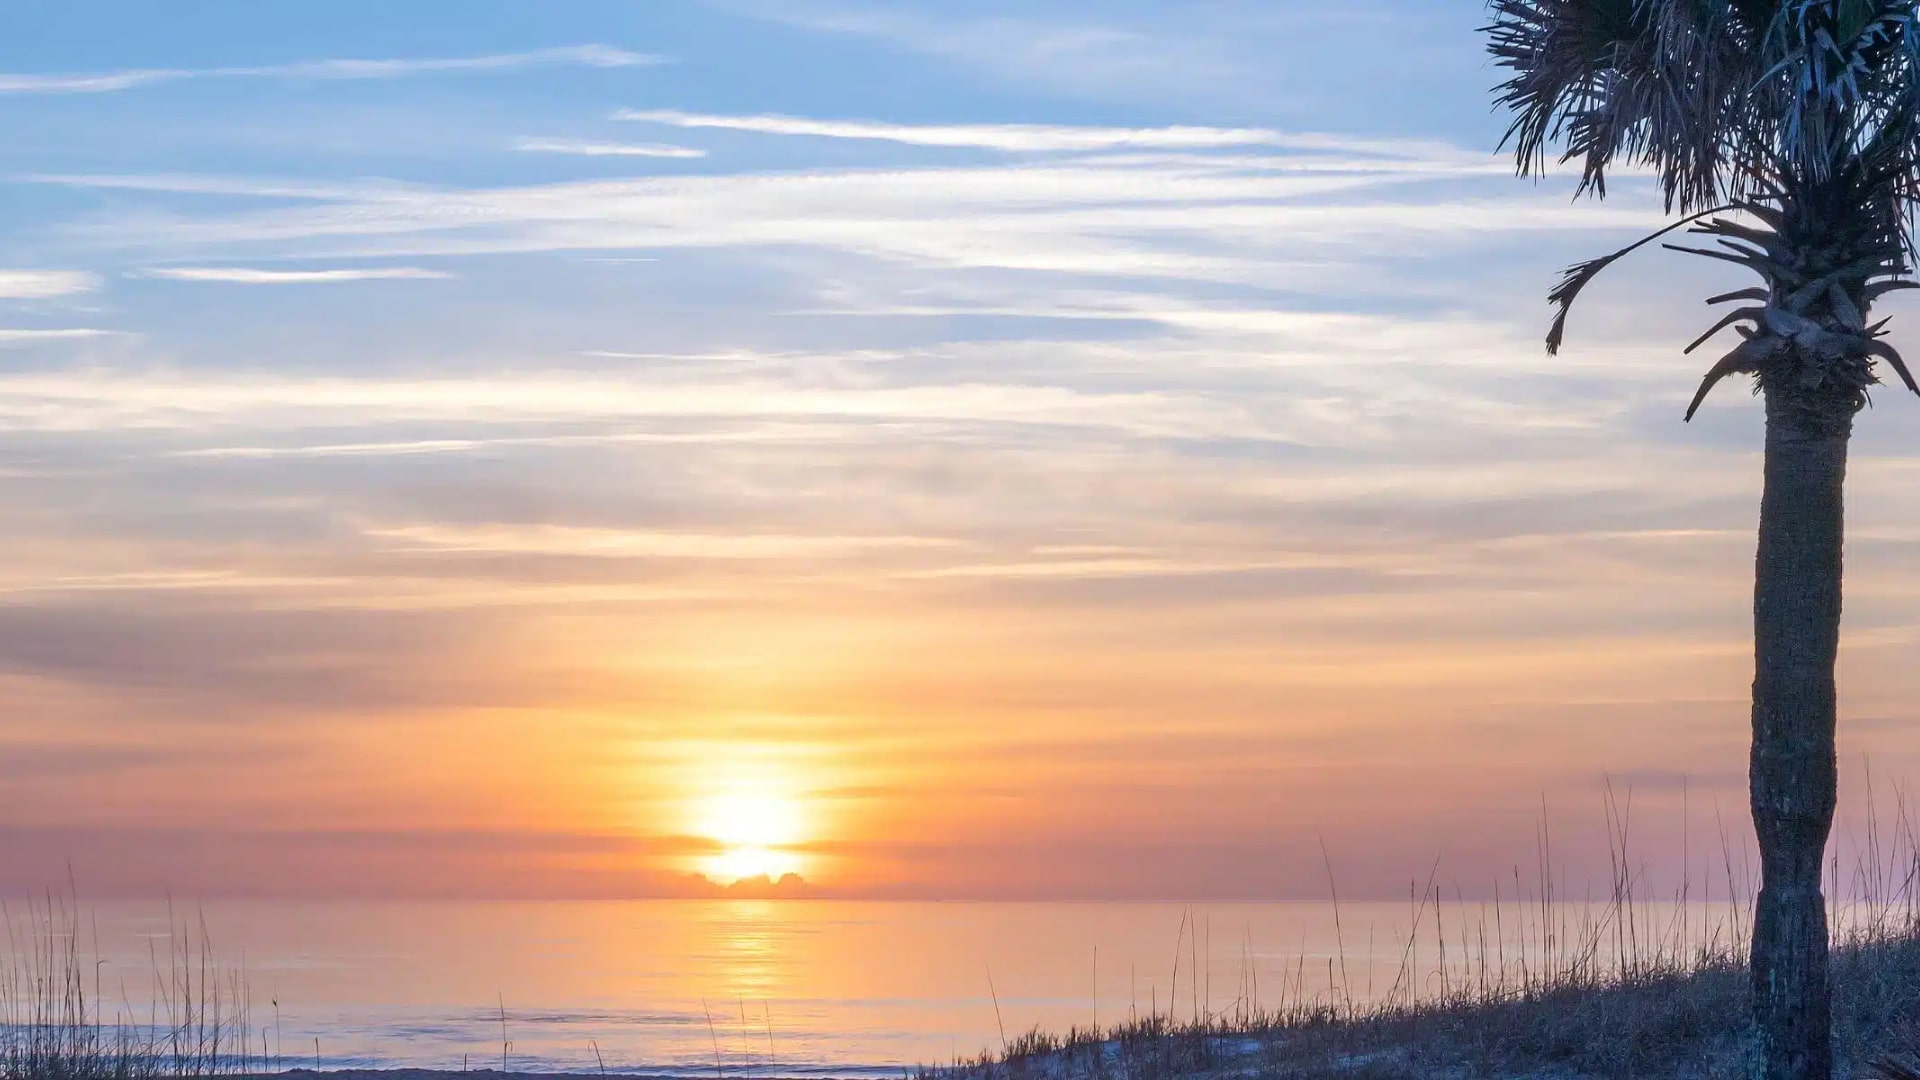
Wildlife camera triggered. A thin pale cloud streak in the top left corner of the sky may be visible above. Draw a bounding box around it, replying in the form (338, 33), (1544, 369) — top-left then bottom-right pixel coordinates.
(0, 44), (662, 94)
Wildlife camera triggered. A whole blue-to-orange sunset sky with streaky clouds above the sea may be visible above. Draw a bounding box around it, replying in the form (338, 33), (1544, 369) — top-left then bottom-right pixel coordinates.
(0, 0), (1920, 901)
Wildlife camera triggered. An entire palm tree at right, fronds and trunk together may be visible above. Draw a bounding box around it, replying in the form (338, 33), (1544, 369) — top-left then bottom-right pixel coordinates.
(1486, 0), (1920, 1080)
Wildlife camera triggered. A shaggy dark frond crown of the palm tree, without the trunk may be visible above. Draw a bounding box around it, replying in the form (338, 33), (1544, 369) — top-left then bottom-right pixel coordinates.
(1486, 0), (1920, 417)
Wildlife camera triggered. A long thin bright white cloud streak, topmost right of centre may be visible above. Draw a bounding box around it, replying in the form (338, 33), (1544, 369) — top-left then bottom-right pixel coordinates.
(612, 110), (1440, 154)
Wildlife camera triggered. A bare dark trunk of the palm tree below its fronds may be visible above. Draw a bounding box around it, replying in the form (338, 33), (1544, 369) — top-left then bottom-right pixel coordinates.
(1749, 386), (1853, 1080)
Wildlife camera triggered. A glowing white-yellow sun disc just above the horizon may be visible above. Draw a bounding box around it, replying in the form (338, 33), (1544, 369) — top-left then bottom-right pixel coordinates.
(691, 769), (808, 884)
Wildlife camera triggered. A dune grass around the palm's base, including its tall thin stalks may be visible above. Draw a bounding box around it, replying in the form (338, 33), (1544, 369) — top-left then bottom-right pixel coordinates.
(916, 796), (1920, 1080)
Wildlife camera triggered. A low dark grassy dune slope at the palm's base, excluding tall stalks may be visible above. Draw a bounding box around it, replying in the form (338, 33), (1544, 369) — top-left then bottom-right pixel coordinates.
(920, 928), (1920, 1080)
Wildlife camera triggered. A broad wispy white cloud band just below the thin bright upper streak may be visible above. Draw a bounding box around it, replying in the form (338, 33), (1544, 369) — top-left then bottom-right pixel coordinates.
(54, 147), (1659, 284)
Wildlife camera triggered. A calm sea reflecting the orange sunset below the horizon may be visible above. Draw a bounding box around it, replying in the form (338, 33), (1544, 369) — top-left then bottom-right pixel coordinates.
(60, 901), (1743, 1076)
